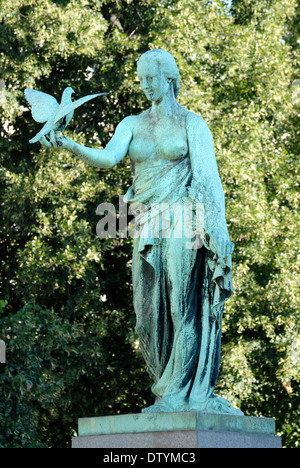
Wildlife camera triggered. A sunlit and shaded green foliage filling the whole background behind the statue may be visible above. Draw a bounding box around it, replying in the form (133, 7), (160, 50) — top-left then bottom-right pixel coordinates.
(0, 0), (300, 447)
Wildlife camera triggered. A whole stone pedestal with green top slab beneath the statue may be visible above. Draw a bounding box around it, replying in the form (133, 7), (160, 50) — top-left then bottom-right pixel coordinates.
(72, 412), (282, 449)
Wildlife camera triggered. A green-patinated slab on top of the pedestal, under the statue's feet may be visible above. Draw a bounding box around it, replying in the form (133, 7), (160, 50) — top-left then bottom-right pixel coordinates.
(78, 412), (275, 436)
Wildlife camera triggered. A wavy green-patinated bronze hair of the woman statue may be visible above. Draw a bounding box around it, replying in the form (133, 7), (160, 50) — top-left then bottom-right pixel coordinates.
(137, 49), (180, 97)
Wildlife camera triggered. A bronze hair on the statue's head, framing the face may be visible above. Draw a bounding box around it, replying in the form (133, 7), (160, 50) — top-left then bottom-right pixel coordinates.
(137, 49), (180, 97)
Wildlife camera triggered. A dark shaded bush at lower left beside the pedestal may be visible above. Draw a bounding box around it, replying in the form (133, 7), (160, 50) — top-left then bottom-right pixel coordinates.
(0, 301), (150, 448)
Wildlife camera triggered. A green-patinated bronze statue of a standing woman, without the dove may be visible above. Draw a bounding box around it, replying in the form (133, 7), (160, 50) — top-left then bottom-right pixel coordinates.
(41, 49), (243, 415)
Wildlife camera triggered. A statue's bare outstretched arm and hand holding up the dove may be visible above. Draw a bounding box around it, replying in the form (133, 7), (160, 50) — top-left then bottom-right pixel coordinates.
(41, 117), (135, 169)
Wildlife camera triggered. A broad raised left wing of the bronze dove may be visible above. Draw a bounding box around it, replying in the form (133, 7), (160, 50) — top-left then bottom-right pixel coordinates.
(24, 88), (59, 123)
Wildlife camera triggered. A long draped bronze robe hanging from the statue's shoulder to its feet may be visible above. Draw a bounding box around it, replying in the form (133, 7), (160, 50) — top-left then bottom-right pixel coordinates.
(125, 113), (233, 411)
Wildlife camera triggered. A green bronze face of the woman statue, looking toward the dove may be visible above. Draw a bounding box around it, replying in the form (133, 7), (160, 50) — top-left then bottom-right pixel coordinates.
(137, 59), (170, 102)
